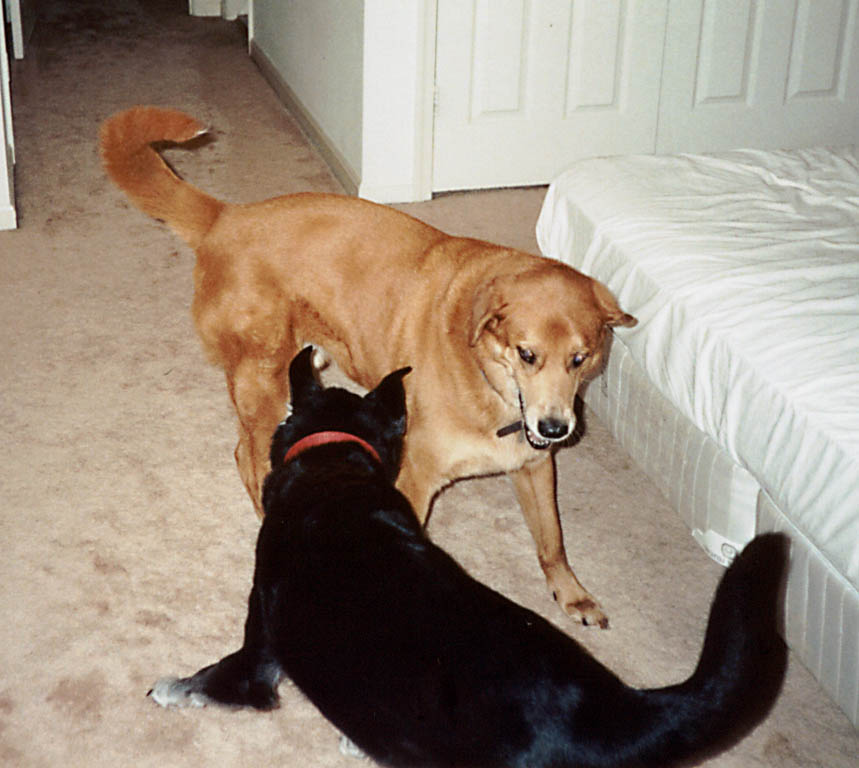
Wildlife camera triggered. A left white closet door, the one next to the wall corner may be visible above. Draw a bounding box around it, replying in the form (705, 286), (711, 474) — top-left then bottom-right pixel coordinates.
(433, 0), (667, 191)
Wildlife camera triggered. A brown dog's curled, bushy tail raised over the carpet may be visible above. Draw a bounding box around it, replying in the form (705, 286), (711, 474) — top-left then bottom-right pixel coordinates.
(101, 107), (224, 248)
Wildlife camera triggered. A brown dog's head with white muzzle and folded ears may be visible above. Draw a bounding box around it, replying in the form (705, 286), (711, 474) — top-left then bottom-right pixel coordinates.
(469, 261), (637, 448)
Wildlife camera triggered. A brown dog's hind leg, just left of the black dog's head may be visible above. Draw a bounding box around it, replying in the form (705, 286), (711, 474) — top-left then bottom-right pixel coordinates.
(227, 357), (291, 517)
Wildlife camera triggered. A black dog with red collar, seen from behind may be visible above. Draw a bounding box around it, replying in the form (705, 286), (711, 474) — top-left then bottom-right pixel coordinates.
(150, 348), (785, 768)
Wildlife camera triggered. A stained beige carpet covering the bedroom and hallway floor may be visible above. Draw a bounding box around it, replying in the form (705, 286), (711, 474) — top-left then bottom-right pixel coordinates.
(0, 0), (859, 768)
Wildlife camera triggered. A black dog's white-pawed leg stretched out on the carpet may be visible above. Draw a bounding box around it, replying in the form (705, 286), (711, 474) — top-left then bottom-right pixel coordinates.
(149, 588), (283, 709)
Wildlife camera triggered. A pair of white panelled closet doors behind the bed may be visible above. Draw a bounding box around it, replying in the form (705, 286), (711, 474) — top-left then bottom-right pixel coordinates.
(432, 0), (859, 191)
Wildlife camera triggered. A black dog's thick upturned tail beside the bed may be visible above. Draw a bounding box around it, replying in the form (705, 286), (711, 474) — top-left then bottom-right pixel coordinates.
(576, 534), (788, 768)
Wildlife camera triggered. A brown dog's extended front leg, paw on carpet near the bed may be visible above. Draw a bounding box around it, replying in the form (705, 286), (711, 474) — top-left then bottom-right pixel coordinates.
(510, 454), (608, 629)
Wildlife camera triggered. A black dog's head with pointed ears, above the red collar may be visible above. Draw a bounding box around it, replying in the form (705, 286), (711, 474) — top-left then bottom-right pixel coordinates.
(271, 347), (411, 482)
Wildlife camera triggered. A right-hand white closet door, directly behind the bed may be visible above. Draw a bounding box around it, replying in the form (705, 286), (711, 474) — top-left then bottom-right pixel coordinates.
(657, 0), (859, 152)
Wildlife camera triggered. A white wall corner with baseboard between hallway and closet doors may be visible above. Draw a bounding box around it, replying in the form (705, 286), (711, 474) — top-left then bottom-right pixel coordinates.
(251, 0), (436, 202)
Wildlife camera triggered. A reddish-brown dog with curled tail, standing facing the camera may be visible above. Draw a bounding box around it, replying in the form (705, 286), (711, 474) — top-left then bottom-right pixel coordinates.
(101, 107), (636, 626)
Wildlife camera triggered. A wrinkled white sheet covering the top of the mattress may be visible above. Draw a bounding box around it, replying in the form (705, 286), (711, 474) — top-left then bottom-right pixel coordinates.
(537, 149), (859, 588)
